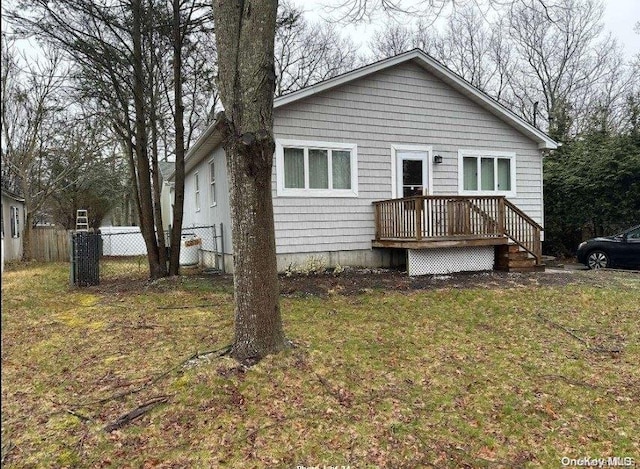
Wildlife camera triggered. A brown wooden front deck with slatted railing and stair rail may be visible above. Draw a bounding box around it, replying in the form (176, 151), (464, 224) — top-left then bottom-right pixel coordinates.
(372, 196), (542, 264)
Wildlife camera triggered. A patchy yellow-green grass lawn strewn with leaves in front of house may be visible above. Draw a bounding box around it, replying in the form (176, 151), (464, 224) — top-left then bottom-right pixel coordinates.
(2, 264), (640, 468)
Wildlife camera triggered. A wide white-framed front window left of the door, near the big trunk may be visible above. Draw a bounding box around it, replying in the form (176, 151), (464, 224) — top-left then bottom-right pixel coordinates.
(276, 140), (358, 197)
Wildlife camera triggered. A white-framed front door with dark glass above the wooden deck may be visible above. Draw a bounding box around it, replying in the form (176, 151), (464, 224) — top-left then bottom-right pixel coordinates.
(395, 149), (430, 197)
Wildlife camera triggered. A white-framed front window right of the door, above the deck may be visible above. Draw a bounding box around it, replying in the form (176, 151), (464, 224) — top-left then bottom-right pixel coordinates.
(458, 150), (516, 197)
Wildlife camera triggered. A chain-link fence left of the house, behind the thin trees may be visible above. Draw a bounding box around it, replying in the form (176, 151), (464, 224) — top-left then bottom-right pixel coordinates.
(71, 224), (224, 285)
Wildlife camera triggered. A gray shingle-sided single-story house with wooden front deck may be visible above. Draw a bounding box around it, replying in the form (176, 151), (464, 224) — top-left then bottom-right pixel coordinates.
(172, 49), (558, 274)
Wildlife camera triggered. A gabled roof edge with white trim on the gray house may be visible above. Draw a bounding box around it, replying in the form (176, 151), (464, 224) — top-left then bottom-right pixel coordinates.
(171, 49), (559, 178)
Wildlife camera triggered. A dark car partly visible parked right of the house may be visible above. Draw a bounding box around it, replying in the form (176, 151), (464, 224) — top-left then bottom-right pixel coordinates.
(578, 225), (640, 269)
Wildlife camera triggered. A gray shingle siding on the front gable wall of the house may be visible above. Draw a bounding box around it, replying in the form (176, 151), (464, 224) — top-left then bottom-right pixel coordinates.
(273, 62), (543, 253)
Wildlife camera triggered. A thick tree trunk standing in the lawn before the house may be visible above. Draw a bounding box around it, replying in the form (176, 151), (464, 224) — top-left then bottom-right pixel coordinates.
(213, 0), (286, 362)
